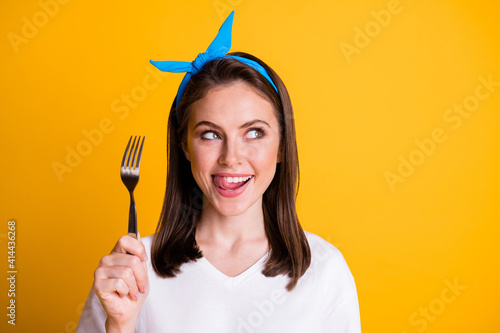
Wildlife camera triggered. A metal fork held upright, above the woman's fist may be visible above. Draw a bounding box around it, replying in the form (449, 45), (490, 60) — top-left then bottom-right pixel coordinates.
(120, 136), (146, 239)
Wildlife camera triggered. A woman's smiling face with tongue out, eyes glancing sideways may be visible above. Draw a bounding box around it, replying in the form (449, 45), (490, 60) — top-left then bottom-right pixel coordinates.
(184, 82), (280, 216)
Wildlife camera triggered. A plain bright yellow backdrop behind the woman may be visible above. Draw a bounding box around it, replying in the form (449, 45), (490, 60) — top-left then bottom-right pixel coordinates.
(0, 0), (500, 333)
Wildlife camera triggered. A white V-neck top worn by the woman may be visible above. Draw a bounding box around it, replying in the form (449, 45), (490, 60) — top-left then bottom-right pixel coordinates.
(76, 232), (361, 333)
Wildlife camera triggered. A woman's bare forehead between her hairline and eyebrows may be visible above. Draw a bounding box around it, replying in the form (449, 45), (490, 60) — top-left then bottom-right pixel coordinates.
(189, 82), (278, 128)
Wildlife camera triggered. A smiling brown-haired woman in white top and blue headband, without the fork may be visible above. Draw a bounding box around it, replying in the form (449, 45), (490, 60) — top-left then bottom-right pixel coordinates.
(77, 13), (360, 332)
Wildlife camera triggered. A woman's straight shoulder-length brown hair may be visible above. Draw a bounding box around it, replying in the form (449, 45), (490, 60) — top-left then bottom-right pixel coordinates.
(151, 52), (311, 291)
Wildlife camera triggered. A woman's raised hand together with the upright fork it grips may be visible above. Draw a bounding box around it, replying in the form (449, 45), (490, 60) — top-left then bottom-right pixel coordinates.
(93, 137), (149, 332)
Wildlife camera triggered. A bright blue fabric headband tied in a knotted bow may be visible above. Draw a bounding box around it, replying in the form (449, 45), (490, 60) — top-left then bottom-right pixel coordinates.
(150, 10), (279, 120)
